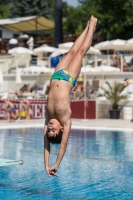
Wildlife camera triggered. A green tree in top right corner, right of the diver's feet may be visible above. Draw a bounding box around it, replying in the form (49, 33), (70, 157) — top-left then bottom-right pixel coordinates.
(79, 0), (133, 39)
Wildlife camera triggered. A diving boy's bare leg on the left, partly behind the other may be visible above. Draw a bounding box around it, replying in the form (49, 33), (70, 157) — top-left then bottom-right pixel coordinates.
(55, 22), (89, 71)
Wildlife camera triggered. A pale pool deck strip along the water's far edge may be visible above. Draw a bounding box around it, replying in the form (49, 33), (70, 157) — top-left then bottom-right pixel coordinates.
(0, 119), (133, 131)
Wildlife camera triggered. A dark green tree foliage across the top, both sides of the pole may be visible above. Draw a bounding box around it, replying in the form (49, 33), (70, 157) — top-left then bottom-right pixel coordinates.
(0, 0), (133, 39)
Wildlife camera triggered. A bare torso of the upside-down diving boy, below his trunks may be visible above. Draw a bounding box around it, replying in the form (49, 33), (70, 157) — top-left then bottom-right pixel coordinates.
(47, 80), (72, 125)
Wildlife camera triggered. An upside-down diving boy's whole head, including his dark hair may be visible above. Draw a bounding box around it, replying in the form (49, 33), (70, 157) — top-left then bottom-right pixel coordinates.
(46, 119), (63, 144)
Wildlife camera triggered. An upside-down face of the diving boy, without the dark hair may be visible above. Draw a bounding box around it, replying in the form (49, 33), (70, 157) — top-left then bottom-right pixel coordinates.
(47, 119), (62, 137)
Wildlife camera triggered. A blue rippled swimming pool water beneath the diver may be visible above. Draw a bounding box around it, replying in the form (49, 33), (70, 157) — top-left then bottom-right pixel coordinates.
(0, 128), (133, 200)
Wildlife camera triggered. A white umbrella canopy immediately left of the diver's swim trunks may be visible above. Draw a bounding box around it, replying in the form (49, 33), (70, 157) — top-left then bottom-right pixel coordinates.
(21, 65), (54, 74)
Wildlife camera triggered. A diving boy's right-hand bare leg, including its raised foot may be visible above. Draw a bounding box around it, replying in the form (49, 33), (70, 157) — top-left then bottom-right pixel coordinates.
(67, 16), (97, 78)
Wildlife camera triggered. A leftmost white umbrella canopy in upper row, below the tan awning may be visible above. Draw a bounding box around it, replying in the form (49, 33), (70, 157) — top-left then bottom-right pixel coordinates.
(8, 47), (34, 54)
